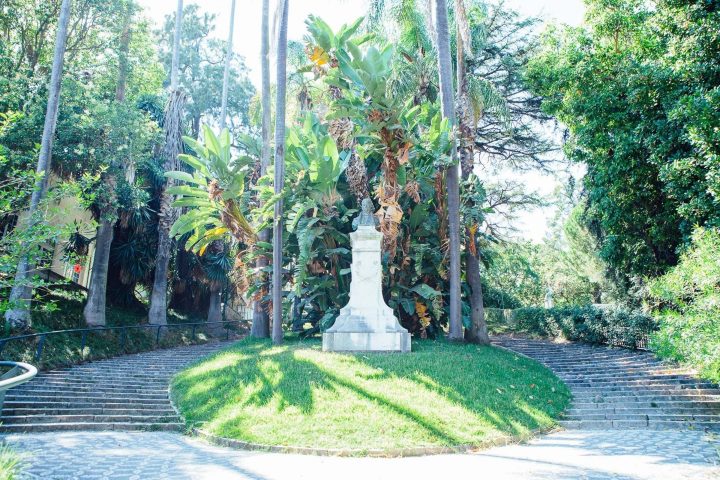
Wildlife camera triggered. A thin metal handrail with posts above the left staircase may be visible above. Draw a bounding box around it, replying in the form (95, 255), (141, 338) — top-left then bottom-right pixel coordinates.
(0, 320), (246, 368)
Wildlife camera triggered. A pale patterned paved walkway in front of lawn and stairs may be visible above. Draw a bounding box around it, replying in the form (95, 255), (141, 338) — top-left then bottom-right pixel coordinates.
(6, 430), (720, 480)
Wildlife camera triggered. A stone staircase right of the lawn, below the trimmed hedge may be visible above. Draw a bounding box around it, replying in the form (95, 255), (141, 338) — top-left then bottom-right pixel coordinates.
(493, 337), (720, 432)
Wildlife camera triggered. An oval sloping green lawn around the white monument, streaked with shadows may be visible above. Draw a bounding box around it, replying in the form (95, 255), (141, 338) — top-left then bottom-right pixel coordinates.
(172, 338), (570, 449)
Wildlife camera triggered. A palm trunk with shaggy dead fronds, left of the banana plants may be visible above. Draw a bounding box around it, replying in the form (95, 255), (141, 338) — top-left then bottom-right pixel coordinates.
(148, 0), (185, 325)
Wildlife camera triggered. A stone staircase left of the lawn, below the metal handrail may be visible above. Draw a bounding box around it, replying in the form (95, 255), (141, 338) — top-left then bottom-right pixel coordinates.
(0, 342), (231, 433)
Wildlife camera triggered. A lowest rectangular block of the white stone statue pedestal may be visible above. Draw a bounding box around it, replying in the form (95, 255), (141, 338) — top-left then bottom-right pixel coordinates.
(323, 332), (410, 353)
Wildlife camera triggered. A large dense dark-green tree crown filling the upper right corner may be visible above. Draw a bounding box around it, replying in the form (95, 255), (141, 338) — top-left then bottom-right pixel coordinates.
(528, 0), (720, 278)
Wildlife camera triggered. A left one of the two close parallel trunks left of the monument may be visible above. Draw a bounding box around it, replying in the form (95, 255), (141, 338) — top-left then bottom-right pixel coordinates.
(250, 0), (270, 338)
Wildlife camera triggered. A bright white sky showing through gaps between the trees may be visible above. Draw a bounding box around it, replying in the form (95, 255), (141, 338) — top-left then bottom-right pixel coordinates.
(139, 0), (585, 242)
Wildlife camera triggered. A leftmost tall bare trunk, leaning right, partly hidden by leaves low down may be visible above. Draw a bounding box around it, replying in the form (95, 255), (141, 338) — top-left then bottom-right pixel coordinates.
(5, 0), (71, 328)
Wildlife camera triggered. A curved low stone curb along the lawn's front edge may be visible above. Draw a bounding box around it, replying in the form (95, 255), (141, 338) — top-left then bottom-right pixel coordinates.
(191, 426), (562, 458)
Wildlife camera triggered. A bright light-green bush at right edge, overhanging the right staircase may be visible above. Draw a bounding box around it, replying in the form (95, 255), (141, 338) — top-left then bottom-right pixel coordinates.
(649, 229), (720, 382)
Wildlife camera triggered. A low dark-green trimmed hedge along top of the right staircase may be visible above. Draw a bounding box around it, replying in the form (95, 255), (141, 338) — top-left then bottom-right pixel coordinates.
(512, 305), (655, 348)
